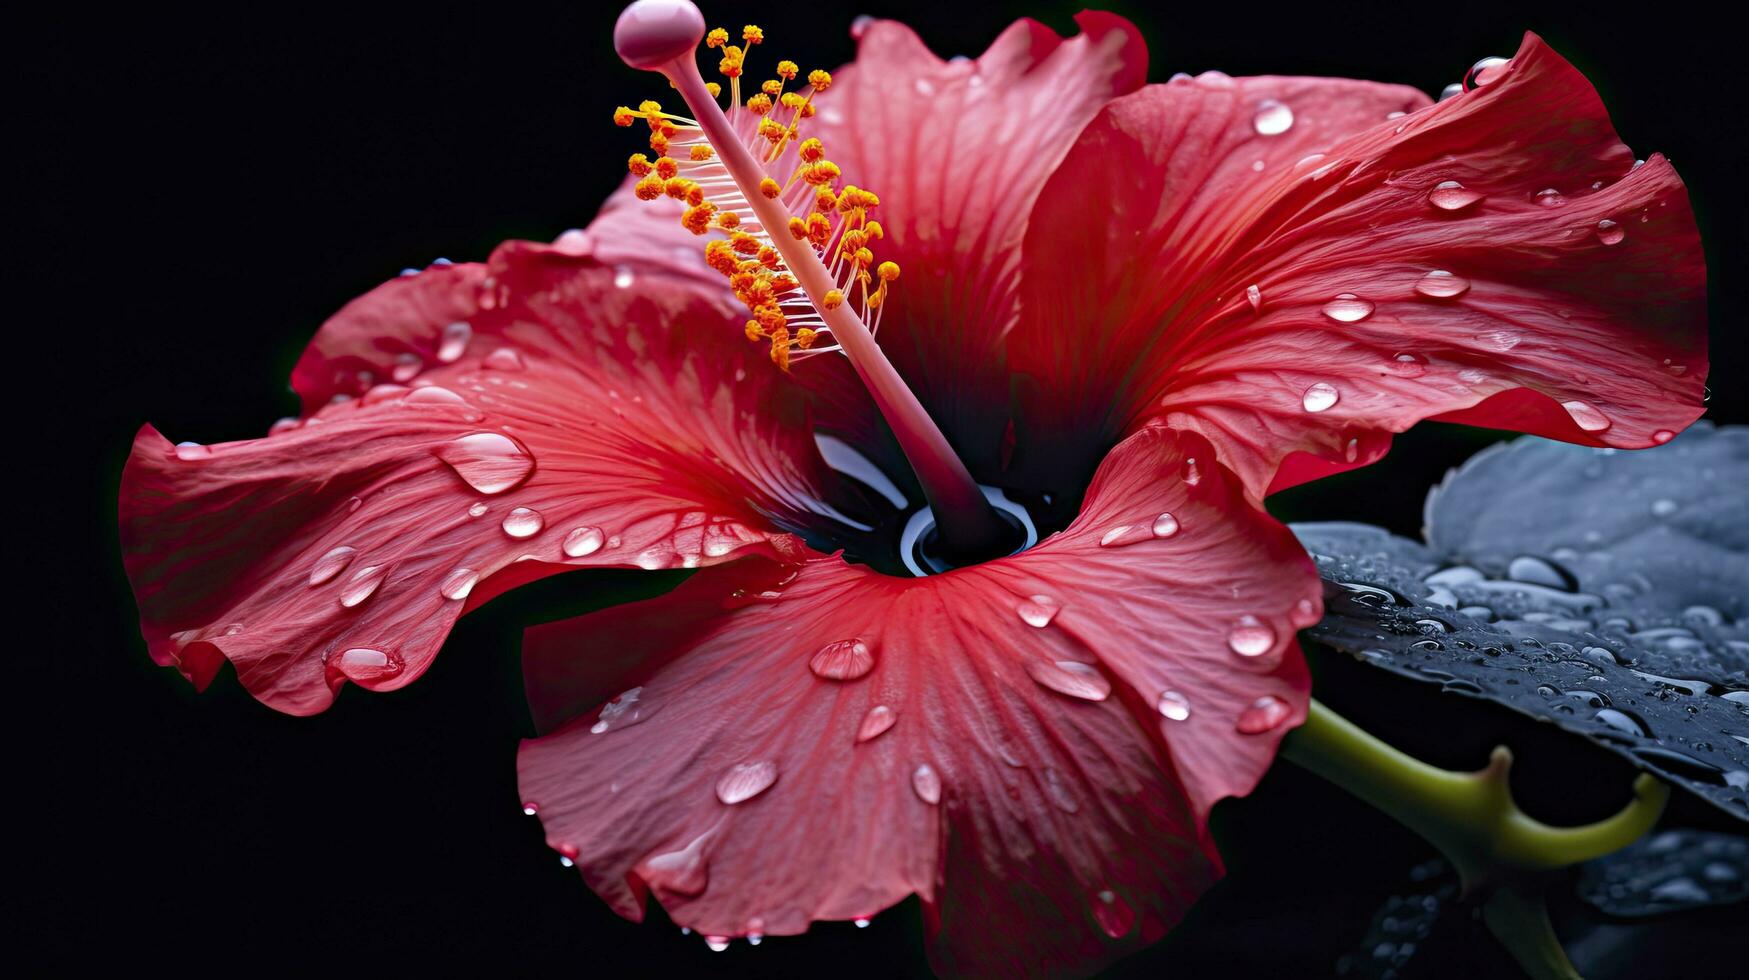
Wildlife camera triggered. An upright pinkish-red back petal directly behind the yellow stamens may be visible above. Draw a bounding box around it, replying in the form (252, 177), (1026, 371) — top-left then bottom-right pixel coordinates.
(810, 11), (1147, 469)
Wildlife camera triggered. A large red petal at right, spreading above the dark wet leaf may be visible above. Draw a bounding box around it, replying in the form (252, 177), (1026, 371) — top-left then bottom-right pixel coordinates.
(1011, 35), (1705, 494)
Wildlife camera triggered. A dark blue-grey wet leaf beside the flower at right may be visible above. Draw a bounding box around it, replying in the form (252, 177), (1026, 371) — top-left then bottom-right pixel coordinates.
(1294, 425), (1749, 819)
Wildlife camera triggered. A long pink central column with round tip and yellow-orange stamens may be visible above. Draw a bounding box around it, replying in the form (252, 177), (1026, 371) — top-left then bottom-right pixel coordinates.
(614, 0), (1013, 564)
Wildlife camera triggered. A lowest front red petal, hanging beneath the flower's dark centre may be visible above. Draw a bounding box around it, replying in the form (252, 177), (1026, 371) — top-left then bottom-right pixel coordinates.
(519, 427), (1319, 975)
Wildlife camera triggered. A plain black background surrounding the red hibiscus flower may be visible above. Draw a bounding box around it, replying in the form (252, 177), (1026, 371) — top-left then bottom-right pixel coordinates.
(17, 0), (1749, 977)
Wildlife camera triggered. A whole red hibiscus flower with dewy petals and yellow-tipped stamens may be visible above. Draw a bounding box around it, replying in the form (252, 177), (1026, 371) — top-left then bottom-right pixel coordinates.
(121, 0), (1705, 973)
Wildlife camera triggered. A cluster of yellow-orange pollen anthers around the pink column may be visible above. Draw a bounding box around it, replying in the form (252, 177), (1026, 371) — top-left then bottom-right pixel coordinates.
(614, 25), (899, 371)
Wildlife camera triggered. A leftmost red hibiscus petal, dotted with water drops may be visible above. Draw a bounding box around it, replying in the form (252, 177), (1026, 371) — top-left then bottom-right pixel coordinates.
(121, 243), (822, 714)
